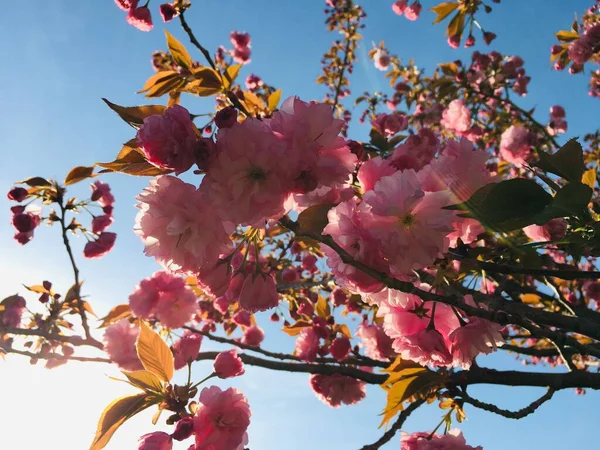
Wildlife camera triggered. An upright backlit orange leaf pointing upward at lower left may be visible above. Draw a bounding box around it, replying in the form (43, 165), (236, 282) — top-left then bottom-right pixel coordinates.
(135, 320), (175, 382)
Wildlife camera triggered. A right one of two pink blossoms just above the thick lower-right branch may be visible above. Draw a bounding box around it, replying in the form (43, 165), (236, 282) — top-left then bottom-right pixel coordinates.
(449, 317), (504, 370)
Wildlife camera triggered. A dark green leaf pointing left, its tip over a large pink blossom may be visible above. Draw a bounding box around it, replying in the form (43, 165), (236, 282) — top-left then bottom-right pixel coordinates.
(445, 178), (552, 231)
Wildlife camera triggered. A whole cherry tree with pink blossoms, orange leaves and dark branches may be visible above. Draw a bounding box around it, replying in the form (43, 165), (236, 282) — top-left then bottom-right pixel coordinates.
(0, 0), (600, 450)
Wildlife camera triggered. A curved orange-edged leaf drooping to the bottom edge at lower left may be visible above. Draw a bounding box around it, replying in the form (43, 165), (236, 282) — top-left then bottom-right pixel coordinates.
(90, 394), (157, 450)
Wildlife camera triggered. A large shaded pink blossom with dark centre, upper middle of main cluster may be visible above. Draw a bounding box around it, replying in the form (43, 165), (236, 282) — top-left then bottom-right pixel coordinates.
(200, 118), (288, 226)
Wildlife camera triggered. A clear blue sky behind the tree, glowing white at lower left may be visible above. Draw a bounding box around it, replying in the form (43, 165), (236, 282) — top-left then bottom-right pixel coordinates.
(0, 0), (600, 450)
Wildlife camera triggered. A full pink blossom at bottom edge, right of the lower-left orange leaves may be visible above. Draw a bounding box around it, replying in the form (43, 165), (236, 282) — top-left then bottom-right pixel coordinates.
(194, 386), (250, 450)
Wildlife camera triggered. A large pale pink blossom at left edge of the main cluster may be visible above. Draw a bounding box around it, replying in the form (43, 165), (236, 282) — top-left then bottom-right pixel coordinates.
(134, 175), (232, 273)
